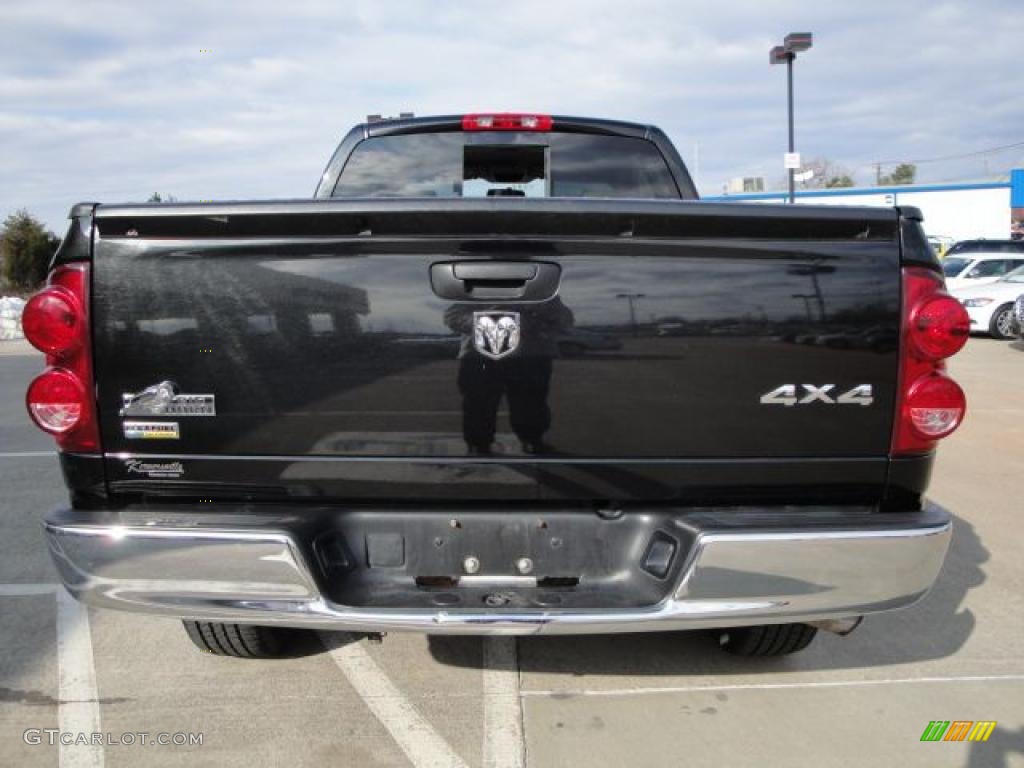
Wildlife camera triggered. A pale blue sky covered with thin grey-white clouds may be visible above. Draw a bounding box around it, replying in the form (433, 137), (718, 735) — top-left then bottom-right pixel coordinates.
(0, 0), (1024, 231)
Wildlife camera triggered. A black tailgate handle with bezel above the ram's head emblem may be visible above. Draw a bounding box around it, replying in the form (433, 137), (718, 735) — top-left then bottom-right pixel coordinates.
(430, 260), (561, 301)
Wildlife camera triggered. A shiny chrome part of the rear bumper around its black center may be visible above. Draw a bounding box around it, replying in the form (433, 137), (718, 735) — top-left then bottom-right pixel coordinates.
(45, 507), (951, 635)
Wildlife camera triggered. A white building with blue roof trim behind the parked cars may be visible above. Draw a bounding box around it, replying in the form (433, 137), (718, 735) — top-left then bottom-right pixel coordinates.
(702, 169), (1024, 240)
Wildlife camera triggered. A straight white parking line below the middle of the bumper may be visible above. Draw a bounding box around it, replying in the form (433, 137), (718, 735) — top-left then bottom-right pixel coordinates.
(483, 637), (524, 768)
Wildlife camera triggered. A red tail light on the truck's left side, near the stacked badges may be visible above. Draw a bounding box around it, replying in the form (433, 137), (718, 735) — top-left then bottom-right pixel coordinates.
(22, 263), (99, 453)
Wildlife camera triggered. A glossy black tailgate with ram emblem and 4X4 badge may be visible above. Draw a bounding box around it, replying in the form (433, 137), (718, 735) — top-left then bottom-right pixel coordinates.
(92, 200), (900, 501)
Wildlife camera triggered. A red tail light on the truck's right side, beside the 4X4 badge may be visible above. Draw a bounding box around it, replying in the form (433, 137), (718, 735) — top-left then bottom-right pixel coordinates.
(893, 267), (971, 455)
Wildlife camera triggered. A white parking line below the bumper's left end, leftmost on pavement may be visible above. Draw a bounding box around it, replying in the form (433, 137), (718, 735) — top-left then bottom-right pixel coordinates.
(57, 590), (103, 768)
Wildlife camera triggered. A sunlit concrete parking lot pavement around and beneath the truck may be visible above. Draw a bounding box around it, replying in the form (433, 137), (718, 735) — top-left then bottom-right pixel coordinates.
(0, 339), (1024, 767)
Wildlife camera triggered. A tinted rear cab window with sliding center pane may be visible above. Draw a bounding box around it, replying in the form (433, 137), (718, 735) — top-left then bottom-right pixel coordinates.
(333, 131), (681, 200)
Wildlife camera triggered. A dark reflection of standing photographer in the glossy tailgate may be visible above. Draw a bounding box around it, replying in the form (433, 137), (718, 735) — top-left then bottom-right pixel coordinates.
(444, 297), (572, 454)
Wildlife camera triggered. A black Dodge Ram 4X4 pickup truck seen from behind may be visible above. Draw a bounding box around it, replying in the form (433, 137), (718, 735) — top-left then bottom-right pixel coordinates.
(24, 114), (969, 656)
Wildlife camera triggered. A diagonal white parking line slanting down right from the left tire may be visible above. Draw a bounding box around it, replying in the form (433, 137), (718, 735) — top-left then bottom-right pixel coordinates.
(321, 633), (466, 768)
